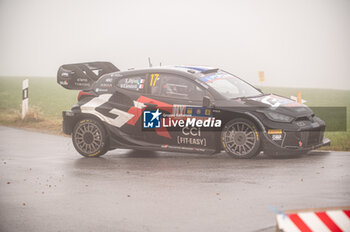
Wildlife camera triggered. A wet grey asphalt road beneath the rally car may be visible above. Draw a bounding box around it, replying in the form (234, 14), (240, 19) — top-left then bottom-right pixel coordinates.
(0, 127), (350, 231)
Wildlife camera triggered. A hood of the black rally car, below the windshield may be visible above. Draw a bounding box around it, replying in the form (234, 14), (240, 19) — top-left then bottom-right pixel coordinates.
(215, 94), (313, 118)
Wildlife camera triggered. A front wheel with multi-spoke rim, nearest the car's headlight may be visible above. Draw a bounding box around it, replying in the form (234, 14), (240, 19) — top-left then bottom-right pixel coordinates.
(221, 118), (260, 159)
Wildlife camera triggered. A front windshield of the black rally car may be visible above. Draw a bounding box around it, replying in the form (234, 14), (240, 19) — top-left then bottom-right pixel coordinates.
(201, 71), (262, 98)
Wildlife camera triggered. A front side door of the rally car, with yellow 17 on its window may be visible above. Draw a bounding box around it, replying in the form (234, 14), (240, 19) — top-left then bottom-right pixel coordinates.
(140, 73), (214, 149)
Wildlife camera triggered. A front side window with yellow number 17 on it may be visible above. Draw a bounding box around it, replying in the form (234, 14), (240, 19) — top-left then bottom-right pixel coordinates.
(149, 73), (205, 101)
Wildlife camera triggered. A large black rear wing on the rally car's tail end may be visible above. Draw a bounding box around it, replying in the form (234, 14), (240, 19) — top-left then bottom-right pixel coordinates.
(57, 62), (120, 90)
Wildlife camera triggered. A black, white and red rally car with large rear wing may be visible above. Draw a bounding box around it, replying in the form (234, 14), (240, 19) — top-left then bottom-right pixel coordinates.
(57, 62), (330, 158)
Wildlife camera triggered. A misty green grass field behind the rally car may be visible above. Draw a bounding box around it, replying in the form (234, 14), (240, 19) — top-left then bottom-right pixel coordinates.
(0, 77), (350, 150)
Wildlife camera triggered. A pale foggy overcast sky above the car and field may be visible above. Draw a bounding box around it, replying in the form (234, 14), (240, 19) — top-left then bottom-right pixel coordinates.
(0, 0), (350, 89)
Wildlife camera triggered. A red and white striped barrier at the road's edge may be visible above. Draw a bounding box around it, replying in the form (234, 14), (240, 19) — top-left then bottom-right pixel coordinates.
(276, 207), (350, 232)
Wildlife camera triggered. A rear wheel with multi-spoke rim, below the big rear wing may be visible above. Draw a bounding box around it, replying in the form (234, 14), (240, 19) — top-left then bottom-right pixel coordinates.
(72, 118), (109, 157)
